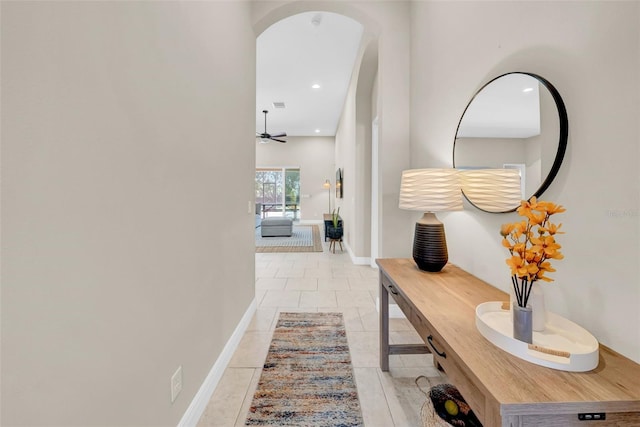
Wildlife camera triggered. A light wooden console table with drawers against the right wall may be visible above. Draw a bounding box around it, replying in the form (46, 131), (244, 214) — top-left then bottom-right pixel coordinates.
(376, 259), (640, 427)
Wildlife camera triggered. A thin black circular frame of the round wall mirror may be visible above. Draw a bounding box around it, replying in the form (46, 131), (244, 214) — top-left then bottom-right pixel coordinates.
(453, 71), (569, 213)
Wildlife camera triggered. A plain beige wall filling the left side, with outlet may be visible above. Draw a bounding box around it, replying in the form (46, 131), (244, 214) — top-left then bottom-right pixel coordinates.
(1, 2), (255, 426)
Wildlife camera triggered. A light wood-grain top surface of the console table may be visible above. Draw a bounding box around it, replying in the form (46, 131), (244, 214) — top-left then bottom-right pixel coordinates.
(376, 259), (640, 414)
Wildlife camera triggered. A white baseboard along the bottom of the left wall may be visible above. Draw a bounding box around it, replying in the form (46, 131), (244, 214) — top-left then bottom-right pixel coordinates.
(178, 298), (258, 427)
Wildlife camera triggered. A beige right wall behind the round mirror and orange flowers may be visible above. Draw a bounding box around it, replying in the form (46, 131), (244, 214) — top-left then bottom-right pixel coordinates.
(407, 1), (640, 362)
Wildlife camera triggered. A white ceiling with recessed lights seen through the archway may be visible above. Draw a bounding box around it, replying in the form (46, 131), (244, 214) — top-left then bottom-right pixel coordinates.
(256, 12), (363, 136)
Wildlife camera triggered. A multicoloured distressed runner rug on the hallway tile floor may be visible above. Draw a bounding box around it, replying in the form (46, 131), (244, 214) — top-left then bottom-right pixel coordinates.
(245, 313), (364, 427)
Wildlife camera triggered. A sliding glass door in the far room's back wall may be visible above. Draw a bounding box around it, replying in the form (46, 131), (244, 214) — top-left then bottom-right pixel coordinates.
(255, 168), (300, 221)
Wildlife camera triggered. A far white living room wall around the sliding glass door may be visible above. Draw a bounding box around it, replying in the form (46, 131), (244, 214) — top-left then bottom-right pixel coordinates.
(256, 136), (336, 221)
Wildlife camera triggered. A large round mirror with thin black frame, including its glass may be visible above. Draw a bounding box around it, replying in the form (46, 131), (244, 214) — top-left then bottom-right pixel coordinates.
(453, 72), (569, 216)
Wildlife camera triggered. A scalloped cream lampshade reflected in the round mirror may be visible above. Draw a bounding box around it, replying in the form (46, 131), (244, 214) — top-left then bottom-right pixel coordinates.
(460, 169), (522, 212)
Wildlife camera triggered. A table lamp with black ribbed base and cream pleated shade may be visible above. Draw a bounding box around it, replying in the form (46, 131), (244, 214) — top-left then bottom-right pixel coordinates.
(399, 169), (462, 272)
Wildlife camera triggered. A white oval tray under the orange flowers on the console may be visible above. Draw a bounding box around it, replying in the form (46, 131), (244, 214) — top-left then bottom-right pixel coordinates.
(476, 301), (599, 372)
